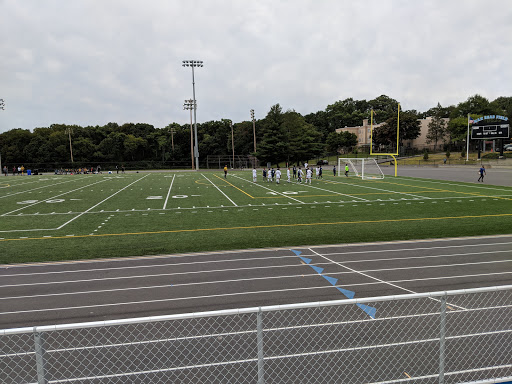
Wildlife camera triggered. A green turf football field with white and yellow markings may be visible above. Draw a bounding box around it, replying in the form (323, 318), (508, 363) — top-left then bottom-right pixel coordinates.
(0, 171), (512, 263)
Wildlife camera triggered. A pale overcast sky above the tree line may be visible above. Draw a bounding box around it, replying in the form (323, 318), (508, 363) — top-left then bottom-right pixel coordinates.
(0, 0), (512, 132)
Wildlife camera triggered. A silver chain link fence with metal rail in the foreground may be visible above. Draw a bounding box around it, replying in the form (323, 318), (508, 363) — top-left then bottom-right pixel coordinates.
(0, 285), (512, 384)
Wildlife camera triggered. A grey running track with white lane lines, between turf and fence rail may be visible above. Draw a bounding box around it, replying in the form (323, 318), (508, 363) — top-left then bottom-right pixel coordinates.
(0, 235), (512, 329)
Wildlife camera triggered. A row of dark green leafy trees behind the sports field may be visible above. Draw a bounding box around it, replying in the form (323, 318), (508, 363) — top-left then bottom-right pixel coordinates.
(0, 95), (512, 166)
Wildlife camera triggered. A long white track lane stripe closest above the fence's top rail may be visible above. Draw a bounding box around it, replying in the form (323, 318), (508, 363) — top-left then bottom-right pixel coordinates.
(0, 272), (512, 315)
